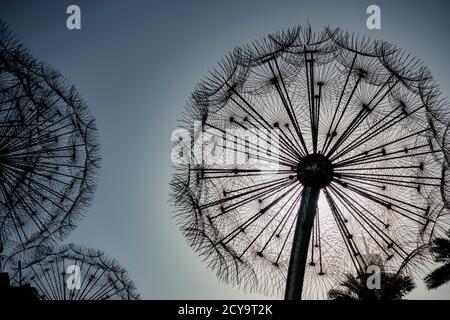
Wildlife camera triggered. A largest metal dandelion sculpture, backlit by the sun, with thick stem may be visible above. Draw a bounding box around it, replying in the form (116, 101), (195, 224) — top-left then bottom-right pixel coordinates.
(172, 28), (449, 299)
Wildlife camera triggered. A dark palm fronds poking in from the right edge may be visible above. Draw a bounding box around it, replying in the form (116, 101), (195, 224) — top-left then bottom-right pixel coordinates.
(425, 230), (450, 289)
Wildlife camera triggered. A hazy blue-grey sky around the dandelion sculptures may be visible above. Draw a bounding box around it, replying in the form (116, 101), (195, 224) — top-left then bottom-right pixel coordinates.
(0, 0), (450, 299)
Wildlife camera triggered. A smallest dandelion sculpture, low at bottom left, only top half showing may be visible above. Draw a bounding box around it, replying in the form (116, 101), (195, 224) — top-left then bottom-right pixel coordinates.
(15, 244), (139, 300)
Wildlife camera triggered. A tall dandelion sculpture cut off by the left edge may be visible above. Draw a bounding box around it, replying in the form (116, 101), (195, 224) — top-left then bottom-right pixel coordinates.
(0, 23), (99, 269)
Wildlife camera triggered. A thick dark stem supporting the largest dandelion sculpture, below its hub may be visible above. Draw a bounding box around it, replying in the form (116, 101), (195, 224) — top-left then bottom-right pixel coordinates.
(284, 186), (320, 300)
